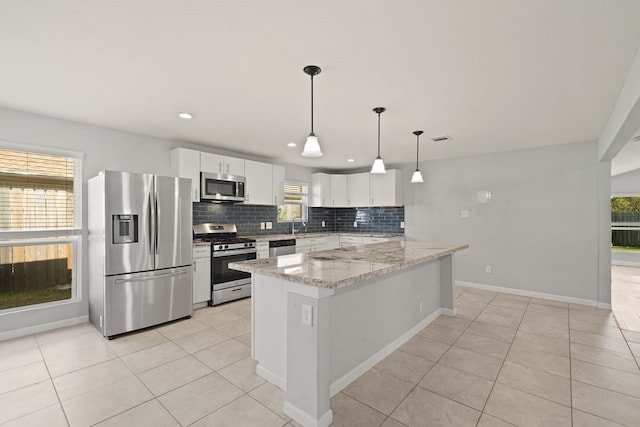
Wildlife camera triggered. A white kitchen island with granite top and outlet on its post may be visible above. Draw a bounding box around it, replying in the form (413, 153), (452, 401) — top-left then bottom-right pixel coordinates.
(229, 242), (468, 426)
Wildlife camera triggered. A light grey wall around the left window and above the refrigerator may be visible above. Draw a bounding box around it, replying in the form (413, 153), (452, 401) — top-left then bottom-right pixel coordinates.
(0, 108), (310, 339)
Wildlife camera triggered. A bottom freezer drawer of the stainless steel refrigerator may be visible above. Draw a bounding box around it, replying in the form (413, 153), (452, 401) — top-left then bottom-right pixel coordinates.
(102, 266), (193, 337)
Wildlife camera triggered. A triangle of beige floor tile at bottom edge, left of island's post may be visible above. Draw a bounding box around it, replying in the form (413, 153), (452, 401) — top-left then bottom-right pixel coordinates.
(192, 395), (287, 427)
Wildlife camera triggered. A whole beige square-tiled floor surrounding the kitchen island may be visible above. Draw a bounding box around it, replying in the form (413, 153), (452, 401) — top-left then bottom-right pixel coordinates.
(0, 287), (640, 427)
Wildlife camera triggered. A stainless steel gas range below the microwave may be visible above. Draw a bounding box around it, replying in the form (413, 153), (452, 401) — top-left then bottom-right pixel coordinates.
(193, 223), (257, 305)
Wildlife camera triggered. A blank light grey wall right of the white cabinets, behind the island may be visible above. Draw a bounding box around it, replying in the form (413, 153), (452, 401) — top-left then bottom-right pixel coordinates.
(404, 142), (610, 304)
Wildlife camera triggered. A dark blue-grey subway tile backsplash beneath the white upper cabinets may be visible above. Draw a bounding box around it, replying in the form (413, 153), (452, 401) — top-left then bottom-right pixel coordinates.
(193, 202), (404, 236)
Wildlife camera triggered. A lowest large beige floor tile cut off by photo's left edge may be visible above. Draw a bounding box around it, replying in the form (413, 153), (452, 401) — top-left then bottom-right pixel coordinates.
(0, 381), (58, 424)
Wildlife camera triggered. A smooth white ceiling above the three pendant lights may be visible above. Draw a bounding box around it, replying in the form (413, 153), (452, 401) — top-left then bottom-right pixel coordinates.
(0, 0), (640, 170)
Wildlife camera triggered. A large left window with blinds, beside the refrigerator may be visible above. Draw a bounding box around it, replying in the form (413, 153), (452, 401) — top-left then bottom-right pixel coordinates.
(0, 148), (82, 310)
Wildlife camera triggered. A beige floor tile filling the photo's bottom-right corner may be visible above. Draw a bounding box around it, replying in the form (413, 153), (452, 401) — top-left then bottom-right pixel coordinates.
(571, 381), (640, 426)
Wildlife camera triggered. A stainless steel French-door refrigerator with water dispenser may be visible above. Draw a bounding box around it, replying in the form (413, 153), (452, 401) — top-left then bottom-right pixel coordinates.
(88, 171), (193, 338)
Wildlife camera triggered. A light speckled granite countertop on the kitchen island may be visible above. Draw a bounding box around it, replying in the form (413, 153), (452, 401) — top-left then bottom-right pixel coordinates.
(229, 241), (469, 289)
